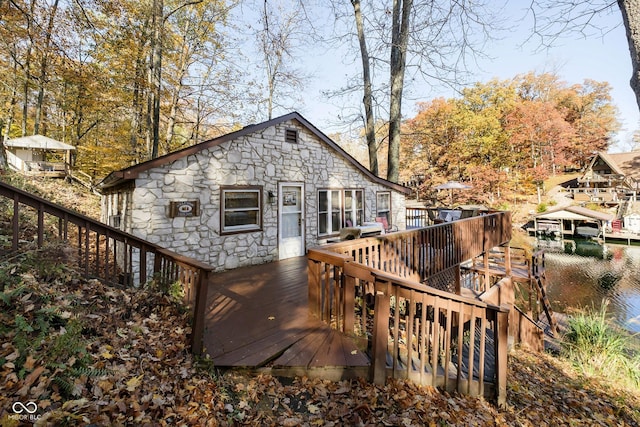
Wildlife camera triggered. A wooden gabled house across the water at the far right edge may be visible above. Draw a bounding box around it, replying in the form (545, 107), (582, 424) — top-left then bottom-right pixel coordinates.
(573, 150), (640, 204)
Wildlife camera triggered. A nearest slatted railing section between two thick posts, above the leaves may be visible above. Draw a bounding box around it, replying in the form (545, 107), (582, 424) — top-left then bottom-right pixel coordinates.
(371, 274), (510, 404)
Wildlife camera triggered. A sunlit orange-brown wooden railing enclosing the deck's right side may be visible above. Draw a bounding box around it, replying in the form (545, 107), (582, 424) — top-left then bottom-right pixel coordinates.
(308, 213), (511, 402)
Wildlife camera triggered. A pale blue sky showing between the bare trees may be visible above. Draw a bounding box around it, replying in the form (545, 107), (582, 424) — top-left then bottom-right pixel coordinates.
(282, 2), (640, 152)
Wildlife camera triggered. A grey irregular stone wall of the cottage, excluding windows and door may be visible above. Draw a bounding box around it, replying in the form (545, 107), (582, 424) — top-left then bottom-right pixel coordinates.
(103, 121), (405, 271)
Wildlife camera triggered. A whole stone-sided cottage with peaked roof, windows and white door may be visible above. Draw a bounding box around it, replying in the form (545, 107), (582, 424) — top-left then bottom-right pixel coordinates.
(99, 112), (410, 271)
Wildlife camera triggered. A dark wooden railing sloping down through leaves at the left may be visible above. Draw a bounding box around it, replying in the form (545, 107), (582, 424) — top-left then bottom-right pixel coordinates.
(0, 182), (213, 354)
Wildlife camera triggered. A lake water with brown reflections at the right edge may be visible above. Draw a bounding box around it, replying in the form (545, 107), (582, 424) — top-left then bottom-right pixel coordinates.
(538, 240), (640, 332)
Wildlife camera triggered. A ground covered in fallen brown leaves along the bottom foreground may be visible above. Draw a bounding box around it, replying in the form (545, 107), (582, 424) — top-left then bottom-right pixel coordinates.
(0, 262), (640, 427)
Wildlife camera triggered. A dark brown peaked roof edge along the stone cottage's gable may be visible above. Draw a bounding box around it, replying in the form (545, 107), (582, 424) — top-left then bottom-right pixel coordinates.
(98, 112), (411, 194)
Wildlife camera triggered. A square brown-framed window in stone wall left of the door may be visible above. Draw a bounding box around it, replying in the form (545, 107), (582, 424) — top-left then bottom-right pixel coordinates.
(221, 187), (262, 233)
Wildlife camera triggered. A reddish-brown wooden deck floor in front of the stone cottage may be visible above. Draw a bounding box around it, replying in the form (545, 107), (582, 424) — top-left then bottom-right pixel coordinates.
(203, 257), (369, 379)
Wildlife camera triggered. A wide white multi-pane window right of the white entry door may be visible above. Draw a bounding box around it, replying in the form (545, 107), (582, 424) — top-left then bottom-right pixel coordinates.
(318, 190), (364, 236)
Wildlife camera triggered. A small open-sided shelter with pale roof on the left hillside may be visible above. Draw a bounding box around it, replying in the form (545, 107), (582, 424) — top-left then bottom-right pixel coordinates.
(4, 135), (76, 178)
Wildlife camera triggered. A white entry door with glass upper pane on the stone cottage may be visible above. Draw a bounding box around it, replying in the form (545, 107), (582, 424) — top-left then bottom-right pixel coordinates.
(278, 182), (305, 259)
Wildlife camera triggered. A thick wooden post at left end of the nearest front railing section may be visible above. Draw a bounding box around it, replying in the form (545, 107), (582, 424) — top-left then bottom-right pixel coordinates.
(370, 279), (391, 385)
